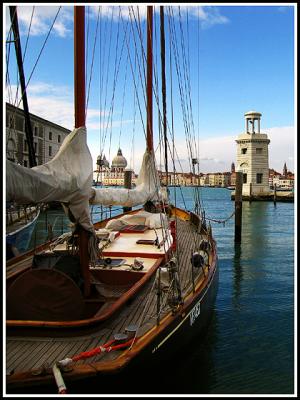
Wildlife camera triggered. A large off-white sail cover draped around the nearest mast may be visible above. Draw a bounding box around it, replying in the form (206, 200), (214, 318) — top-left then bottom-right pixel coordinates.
(6, 127), (93, 232)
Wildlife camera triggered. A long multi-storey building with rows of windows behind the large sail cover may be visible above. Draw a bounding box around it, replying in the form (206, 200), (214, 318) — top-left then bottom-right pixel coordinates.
(6, 103), (71, 167)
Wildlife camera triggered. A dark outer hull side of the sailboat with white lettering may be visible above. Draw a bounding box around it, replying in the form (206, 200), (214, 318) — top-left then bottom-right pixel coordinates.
(7, 260), (219, 393)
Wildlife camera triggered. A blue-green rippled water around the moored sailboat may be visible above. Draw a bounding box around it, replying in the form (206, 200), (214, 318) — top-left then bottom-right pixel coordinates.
(27, 188), (294, 395)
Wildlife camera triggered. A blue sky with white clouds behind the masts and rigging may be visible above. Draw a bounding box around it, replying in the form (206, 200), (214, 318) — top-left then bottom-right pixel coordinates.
(3, 3), (297, 173)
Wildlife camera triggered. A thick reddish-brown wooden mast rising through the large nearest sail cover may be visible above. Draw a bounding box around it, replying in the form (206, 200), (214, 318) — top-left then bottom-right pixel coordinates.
(74, 6), (91, 296)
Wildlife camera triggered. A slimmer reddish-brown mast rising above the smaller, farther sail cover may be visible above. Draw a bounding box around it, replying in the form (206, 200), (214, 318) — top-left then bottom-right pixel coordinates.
(147, 6), (153, 152)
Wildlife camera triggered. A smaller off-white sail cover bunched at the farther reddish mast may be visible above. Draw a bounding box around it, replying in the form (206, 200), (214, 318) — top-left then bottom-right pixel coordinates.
(91, 151), (163, 207)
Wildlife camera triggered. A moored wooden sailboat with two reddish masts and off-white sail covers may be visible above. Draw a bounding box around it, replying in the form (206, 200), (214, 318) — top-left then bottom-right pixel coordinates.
(6, 6), (218, 393)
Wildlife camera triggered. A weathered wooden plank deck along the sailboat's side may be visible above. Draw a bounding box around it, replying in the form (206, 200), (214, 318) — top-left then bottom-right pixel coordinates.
(6, 219), (209, 378)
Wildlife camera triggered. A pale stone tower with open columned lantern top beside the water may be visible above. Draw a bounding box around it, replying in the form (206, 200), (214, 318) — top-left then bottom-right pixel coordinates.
(236, 111), (270, 196)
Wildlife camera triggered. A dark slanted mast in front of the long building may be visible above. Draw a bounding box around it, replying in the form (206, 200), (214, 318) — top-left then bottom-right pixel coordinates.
(9, 6), (37, 168)
